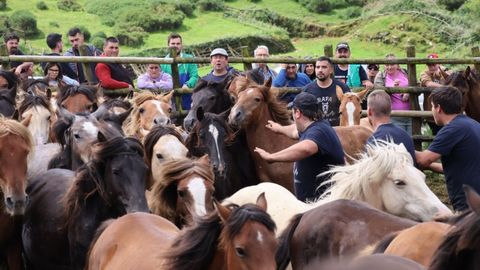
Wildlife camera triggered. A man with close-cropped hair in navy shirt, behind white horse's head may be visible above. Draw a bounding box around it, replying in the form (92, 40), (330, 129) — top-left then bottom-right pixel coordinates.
(367, 90), (416, 164)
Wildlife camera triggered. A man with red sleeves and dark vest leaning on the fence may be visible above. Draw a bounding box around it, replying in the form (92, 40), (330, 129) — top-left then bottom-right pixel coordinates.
(95, 37), (134, 90)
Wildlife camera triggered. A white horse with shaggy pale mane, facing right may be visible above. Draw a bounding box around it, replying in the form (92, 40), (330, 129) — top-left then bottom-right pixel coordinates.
(223, 141), (452, 234)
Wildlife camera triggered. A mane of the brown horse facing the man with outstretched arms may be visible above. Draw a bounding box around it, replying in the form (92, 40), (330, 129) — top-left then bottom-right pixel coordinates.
(256, 85), (292, 125)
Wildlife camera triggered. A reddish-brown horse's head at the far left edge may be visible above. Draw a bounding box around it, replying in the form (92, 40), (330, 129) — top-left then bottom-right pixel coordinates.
(0, 118), (33, 216)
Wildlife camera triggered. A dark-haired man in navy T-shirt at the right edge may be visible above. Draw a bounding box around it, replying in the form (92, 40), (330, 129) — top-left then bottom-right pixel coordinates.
(416, 86), (480, 211)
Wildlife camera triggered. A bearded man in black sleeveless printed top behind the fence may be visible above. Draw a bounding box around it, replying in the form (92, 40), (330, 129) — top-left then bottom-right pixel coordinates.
(303, 56), (350, 126)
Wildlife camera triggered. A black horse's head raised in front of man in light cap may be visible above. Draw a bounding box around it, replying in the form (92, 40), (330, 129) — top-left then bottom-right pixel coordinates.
(183, 77), (232, 131)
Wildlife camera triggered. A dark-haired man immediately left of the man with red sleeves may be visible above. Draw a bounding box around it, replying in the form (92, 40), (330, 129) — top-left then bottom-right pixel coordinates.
(65, 27), (102, 83)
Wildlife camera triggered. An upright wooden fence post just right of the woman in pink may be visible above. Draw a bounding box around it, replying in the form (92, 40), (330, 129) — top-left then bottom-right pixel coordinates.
(407, 45), (422, 150)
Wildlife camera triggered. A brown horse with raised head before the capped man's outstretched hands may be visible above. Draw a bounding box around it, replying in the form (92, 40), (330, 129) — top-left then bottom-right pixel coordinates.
(228, 79), (296, 191)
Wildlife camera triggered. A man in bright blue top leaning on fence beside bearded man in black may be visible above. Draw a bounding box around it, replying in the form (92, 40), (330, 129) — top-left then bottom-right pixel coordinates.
(272, 61), (311, 103)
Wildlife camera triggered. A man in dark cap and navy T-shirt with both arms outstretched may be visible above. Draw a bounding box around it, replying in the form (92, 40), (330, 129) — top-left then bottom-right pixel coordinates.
(255, 92), (344, 201)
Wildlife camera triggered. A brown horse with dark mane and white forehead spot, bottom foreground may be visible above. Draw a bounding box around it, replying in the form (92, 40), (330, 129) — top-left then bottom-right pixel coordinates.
(87, 193), (277, 270)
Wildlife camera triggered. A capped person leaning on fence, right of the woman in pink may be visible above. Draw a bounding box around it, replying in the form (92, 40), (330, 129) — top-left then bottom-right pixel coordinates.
(420, 53), (451, 135)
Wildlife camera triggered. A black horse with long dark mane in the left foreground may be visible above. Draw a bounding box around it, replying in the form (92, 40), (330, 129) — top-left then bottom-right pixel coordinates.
(22, 131), (149, 269)
